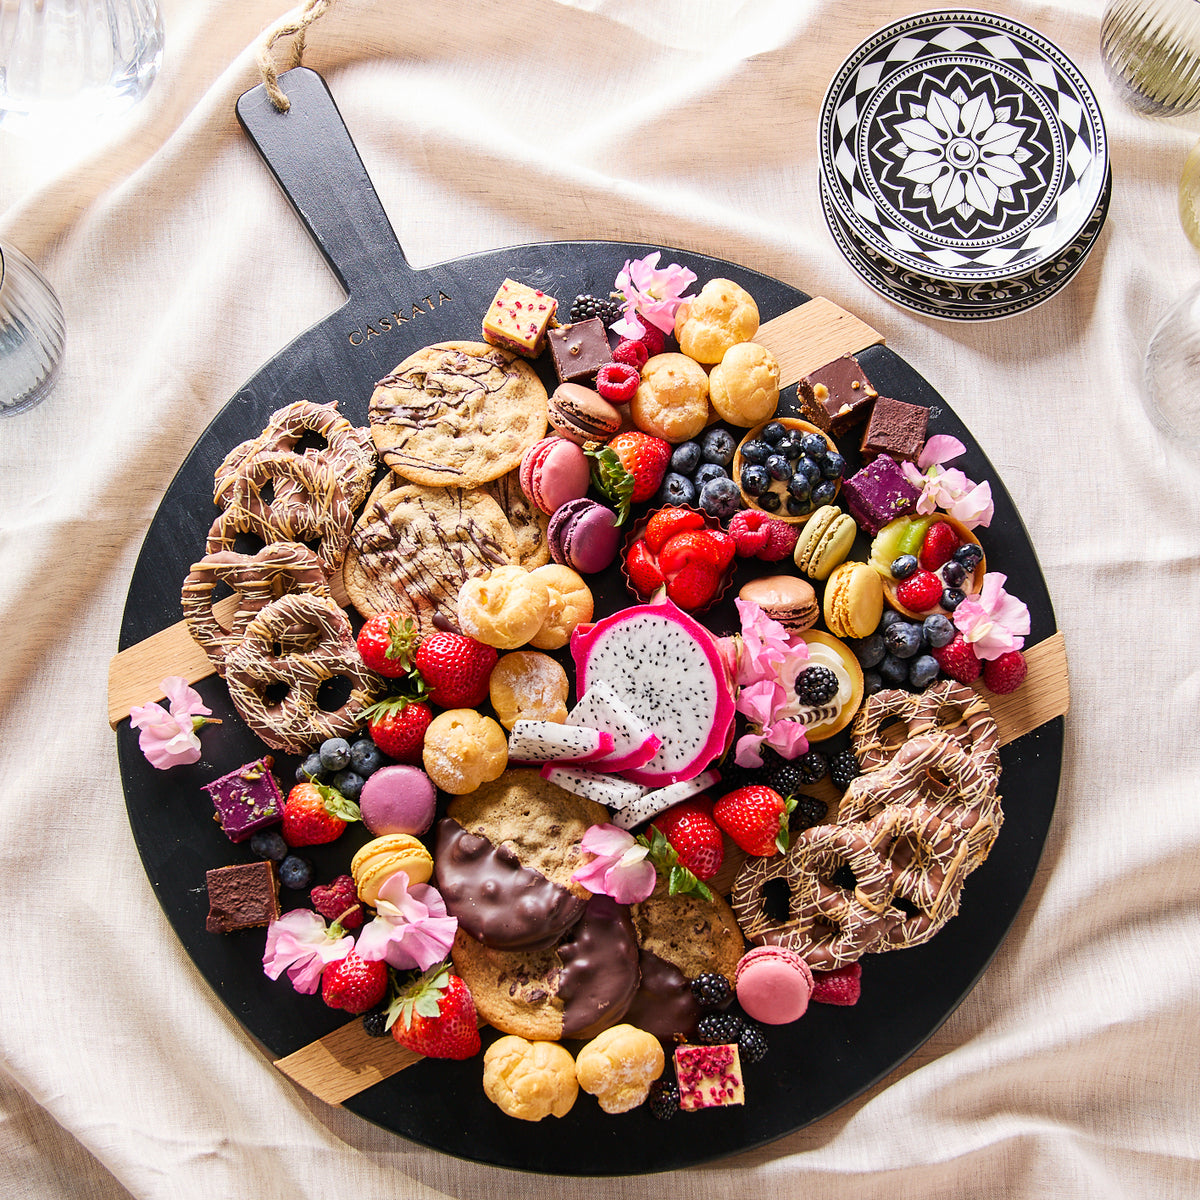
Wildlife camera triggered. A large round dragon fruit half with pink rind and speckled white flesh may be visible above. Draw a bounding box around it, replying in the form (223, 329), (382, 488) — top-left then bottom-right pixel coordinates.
(571, 600), (733, 787)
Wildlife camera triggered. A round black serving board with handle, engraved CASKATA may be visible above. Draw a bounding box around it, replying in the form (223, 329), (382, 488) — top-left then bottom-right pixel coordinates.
(118, 68), (1062, 1175)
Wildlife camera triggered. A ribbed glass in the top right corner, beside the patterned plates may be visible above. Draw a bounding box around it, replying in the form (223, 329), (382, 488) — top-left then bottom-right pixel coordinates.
(1100, 0), (1200, 116)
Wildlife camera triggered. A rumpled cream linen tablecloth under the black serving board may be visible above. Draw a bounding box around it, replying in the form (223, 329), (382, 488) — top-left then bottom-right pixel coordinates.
(0, 0), (1200, 1200)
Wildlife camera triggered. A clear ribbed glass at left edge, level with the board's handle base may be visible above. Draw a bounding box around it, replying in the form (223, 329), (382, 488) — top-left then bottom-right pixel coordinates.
(0, 244), (66, 416)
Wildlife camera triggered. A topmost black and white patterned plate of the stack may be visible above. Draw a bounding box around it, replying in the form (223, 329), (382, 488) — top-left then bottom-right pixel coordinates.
(820, 10), (1109, 282)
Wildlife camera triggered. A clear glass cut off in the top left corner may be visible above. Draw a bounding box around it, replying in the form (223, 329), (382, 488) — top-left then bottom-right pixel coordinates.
(0, 0), (163, 132)
